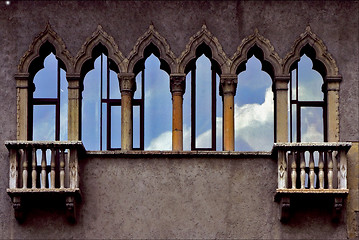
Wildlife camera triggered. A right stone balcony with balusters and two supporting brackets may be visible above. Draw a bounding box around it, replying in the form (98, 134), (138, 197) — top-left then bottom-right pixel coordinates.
(273, 142), (351, 221)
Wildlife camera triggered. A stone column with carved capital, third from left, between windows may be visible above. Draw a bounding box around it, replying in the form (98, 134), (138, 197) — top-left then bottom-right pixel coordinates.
(118, 73), (136, 151)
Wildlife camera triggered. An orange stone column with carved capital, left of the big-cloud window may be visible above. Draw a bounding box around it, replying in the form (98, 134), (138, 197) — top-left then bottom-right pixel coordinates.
(220, 74), (238, 151)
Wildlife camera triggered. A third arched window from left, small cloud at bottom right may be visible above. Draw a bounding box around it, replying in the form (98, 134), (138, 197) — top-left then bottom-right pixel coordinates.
(132, 43), (172, 150)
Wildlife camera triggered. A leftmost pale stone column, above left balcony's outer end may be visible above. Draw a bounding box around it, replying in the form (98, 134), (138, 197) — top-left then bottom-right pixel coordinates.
(15, 73), (29, 140)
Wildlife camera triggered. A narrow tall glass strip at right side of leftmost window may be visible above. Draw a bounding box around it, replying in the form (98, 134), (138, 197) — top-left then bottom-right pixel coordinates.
(60, 69), (68, 141)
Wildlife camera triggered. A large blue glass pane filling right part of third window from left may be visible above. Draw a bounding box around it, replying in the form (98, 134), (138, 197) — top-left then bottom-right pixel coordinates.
(144, 54), (172, 150)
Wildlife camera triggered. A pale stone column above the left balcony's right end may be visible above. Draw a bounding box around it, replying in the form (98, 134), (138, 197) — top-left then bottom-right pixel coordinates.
(66, 74), (82, 141)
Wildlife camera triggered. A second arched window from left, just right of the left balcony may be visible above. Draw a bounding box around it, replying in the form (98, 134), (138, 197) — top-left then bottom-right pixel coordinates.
(81, 44), (121, 150)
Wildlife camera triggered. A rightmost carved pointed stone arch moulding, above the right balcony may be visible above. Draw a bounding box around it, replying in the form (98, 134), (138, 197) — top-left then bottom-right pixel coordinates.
(283, 26), (339, 77)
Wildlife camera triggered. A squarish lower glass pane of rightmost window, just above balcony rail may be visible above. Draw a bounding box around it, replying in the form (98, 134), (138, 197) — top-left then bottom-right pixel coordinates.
(300, 107), (324, 142)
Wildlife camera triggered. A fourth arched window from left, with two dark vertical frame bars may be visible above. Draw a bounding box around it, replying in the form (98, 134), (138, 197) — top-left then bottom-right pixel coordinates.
(183, 44), (223, 150)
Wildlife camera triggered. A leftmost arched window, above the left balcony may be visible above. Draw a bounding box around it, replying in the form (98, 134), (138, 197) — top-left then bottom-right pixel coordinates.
(28, 42), (68, 141)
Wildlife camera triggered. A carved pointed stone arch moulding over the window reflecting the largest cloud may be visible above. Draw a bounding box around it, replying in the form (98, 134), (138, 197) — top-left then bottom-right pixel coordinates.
(230, 29), (282, 80)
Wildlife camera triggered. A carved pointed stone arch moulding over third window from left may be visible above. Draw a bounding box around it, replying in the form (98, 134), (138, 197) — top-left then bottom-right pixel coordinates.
(127, 24), (177, 73)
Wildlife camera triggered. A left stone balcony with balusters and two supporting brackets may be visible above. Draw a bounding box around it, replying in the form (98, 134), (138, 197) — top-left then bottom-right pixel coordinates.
(5, 141), (84, 221)
